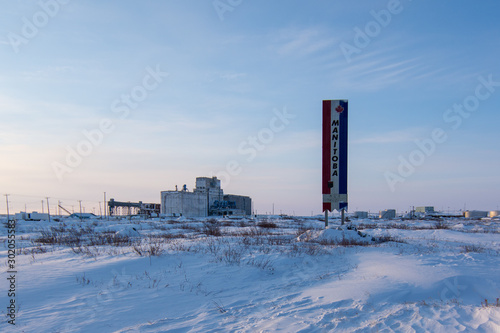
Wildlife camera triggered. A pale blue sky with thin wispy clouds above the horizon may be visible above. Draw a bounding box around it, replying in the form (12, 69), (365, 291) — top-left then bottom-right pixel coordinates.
(0, 0), (500, 215)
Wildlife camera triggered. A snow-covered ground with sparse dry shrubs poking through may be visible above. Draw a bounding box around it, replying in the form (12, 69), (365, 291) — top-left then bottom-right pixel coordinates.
(0, 217), (500, 333)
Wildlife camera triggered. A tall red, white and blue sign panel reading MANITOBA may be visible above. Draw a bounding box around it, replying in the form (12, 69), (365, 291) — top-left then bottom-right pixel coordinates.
(322, 100), (349, 211)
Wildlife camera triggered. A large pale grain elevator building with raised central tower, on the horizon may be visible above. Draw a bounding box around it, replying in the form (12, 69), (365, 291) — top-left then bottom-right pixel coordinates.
(161, 177), (252, 217)
